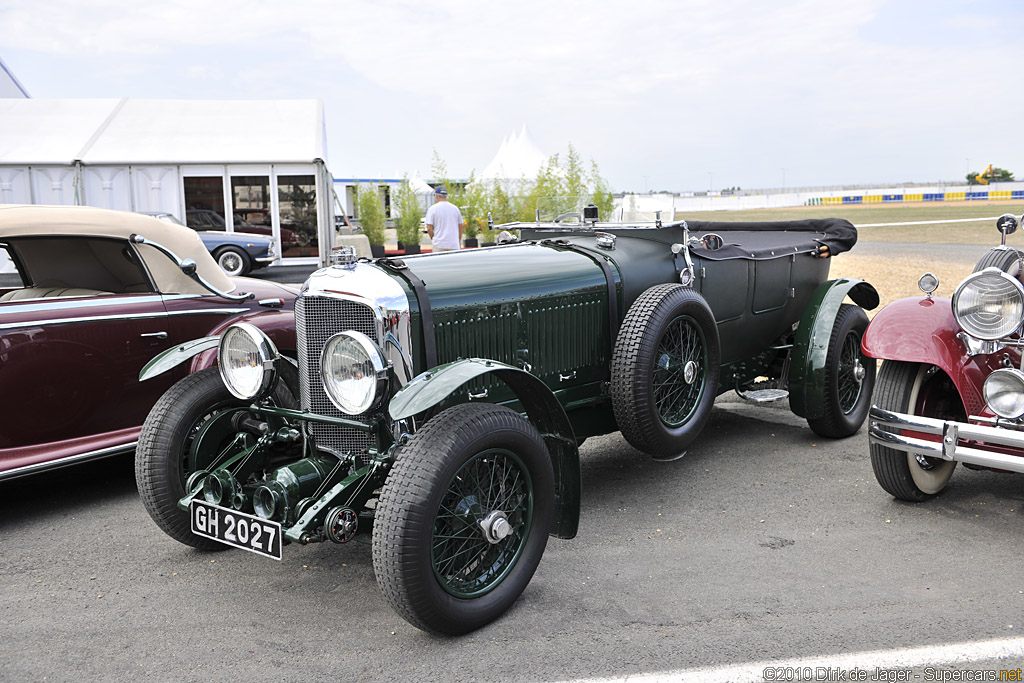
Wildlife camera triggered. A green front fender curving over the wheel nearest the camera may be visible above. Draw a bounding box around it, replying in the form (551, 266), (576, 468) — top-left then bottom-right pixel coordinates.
(388, 358), (582, 539)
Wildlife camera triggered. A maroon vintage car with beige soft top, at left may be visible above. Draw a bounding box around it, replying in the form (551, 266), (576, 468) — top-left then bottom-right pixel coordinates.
(0, 205), (298, 479)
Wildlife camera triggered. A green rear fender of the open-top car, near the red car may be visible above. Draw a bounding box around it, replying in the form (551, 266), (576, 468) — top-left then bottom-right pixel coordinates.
(788, 278), (879, 420)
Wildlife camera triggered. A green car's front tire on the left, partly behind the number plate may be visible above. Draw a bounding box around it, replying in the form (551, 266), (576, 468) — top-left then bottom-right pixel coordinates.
(135, 368), (296, 550)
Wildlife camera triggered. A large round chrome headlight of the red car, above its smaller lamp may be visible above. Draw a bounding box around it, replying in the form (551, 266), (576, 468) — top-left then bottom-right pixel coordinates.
(953, 268), (1024, 341)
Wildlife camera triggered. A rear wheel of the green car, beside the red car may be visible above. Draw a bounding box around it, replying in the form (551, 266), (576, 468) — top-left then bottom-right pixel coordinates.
(807, 303), (876, 438)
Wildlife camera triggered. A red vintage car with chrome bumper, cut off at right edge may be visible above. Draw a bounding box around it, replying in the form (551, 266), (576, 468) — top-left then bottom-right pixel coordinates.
(862, 214), (1024, 501)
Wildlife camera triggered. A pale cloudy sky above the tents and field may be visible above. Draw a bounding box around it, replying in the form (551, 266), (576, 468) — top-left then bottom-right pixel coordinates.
(0, 0), (1024, 191)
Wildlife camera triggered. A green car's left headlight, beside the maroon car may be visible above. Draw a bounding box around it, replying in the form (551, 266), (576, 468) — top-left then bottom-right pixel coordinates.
(217, 323), (280, 400)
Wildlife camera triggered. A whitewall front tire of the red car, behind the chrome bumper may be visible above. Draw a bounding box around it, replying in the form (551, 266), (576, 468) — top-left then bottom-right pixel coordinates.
(870, 360), (967, 503)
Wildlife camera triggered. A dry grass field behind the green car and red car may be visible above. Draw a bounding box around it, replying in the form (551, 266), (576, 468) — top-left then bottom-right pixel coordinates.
(685, 202), (1024, 314)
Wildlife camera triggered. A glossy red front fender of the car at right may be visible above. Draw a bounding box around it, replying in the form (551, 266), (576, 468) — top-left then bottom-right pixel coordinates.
(860, 297), (1006, 415)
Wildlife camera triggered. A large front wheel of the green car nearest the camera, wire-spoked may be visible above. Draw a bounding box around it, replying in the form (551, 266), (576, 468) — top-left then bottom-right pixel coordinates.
(373, 403), (555, 635)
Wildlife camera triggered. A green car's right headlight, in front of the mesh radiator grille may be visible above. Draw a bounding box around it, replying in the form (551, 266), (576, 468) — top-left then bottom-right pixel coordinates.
(319, 330), (389, 415)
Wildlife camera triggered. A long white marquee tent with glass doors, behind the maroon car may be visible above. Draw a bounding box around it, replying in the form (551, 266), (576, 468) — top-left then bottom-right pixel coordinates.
(0, 98), (334, 263)
